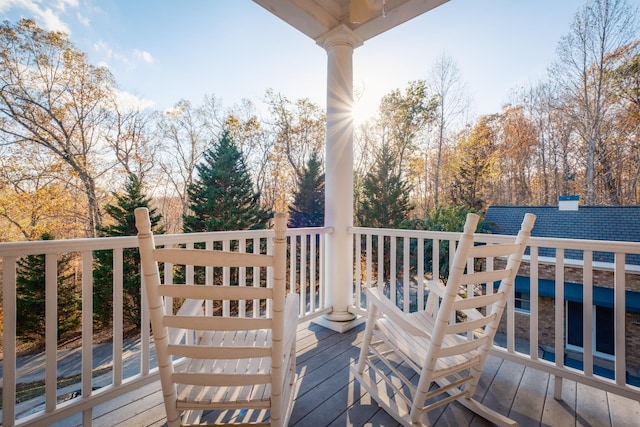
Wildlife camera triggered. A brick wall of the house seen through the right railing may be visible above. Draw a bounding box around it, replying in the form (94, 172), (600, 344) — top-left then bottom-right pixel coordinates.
(496, 262), (640, 376)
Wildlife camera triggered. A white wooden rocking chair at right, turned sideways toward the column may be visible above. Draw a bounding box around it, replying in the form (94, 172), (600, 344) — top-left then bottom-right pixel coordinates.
(351, 214), (535, 426)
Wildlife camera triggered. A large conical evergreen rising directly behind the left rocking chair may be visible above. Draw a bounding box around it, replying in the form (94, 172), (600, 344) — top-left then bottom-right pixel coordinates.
(183, 131), (271, 233)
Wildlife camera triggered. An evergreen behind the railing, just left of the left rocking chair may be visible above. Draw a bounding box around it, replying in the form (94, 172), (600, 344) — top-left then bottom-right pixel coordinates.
(93, 175), (163, 326)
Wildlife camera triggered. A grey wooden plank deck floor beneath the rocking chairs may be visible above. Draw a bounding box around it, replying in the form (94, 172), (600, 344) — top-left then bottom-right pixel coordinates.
(70, 322), (640, 427)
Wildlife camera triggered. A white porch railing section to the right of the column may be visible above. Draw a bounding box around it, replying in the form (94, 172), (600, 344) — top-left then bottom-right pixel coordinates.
(352, 228), (640, 400)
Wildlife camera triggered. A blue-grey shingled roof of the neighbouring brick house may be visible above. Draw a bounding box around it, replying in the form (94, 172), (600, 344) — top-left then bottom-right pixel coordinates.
(484, 206), (640, 264)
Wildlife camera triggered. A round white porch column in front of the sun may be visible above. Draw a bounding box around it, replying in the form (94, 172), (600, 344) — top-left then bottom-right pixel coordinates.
(317, 25), (362, 330)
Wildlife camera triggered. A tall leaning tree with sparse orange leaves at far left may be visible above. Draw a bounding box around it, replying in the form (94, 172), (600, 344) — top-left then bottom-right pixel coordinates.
(0, 19), (114, 237)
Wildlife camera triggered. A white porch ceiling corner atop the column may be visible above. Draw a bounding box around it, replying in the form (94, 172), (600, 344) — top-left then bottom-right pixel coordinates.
(254, 0), (449, 42)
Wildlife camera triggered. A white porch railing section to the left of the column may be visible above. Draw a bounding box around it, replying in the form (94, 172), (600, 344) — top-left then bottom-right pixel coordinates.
(0, 228), (330, 427)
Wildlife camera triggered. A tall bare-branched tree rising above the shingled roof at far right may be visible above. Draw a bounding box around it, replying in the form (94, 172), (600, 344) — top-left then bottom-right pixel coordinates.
(553, 0), (638, 205)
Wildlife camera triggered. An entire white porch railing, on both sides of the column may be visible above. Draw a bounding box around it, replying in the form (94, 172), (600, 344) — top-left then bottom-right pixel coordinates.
(0, 228), (640, 426)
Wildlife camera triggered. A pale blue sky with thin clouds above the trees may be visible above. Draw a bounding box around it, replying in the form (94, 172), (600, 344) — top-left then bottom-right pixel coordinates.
(0, 0), (616, 122)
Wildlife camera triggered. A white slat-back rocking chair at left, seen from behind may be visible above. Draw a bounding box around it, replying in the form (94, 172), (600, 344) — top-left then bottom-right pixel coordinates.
(135, 208), (299, 427)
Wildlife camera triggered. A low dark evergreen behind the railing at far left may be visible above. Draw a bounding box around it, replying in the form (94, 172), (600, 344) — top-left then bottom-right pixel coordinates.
(16, 233), (80, 342)
